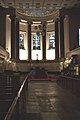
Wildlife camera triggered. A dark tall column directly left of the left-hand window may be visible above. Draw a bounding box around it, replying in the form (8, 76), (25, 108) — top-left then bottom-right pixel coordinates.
(16, 18), (19, 60)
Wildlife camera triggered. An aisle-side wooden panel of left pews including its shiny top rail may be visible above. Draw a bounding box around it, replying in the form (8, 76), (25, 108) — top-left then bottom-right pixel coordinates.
(4, 76), (28, 120)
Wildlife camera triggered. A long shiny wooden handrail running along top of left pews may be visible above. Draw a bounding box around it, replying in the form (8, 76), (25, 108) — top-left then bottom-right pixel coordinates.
(4, 76), (28, 120)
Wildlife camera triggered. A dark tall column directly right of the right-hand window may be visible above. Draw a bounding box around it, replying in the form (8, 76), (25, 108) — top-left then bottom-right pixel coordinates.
(55, 19), (59, 60)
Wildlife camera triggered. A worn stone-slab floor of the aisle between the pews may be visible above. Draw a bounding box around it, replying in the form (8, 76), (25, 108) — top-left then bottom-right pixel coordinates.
(20, 81), (80, 120)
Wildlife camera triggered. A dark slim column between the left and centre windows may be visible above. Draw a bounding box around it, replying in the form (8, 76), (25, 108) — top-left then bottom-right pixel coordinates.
(28, 22), (31, 60)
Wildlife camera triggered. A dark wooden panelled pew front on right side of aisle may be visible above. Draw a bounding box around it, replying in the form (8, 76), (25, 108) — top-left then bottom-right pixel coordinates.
(57, 75), (80, 96)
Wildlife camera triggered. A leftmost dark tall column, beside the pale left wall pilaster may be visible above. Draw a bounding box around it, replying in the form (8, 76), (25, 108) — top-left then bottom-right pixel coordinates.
(11, 15), (16, 60)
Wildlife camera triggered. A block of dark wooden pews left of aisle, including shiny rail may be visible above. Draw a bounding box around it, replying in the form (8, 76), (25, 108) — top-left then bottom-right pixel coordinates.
(0, 71), (28, 120)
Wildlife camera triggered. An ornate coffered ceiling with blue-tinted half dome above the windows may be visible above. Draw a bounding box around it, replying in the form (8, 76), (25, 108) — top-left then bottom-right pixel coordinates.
(0, 0), (80, 18)
